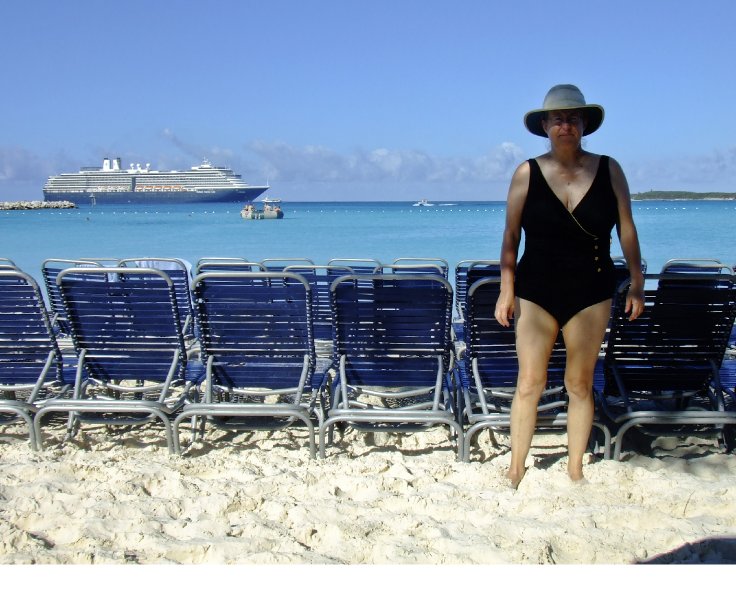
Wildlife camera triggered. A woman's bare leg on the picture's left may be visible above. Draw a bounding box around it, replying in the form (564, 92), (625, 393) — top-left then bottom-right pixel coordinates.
(507, 299), (559, 489)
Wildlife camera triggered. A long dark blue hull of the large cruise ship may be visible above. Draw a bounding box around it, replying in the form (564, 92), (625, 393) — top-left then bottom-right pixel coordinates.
(43, 186), (268, 206)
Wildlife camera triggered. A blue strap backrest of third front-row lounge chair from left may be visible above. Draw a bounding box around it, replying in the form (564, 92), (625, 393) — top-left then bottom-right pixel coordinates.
(192, 272), (316, 389)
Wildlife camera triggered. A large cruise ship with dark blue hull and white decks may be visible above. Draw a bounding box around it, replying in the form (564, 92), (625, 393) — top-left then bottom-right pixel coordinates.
(43, 158), (268, 205)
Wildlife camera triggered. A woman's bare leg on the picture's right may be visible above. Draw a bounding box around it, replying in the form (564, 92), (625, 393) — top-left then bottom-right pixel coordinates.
(562, 300), (611, 481)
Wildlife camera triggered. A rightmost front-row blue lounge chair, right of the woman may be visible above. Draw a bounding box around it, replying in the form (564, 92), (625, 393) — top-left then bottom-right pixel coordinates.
(601, 272), (736, 459)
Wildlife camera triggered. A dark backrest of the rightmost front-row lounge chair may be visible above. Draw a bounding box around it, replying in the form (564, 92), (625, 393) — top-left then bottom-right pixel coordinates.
(605, 273), (736, 395)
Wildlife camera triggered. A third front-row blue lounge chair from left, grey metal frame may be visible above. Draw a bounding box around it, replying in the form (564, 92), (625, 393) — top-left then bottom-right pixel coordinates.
(174, 272), (323, 457)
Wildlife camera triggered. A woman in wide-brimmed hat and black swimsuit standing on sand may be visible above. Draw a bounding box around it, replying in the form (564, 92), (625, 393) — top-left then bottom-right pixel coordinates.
(495, 84), (644, 489)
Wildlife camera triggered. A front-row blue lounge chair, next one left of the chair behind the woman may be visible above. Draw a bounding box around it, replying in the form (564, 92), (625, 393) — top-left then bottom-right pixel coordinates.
(320, 274), (464, 460)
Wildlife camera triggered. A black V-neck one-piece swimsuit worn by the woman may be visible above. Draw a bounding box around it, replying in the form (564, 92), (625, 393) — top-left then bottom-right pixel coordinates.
(514, 156), (618, 327)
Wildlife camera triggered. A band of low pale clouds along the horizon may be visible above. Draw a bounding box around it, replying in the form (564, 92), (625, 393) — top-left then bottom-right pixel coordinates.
(7, 134), (736, 199)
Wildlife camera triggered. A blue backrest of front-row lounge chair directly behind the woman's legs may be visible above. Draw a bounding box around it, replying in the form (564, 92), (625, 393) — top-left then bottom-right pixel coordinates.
(464, 277), (566, 389)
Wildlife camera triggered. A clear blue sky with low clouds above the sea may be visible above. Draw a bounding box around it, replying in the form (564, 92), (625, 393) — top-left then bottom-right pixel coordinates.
(0, 0), (736, 201)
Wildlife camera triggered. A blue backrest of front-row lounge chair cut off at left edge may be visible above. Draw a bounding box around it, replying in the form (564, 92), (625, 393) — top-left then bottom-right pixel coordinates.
(0, 269), (62, 386)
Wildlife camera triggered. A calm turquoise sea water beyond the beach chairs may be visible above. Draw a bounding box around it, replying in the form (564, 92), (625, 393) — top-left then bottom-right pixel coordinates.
(0, 201), (736, 284)
